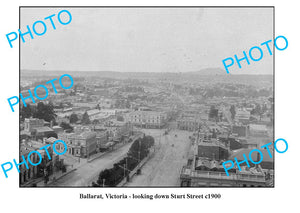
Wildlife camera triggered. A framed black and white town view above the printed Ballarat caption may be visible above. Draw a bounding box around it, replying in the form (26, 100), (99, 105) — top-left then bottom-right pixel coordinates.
(17, 6), (274, 188)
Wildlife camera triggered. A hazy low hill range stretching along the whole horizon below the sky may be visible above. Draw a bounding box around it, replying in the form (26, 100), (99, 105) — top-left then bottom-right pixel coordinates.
(21, 68), (273, 87)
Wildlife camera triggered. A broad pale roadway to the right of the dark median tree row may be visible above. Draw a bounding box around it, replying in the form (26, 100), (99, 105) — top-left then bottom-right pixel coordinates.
(125, 129), (192, 187)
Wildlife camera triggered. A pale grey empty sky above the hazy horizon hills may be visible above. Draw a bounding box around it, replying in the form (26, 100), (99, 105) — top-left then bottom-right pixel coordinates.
(20, 8), (273, 74)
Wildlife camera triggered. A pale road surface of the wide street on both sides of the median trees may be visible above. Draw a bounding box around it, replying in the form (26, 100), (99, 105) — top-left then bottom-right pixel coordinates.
(22, 129), (192, 187)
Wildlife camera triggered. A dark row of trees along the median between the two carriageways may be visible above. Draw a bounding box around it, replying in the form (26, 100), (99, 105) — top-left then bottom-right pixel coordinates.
(92, 136), (154, 187)
